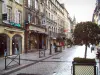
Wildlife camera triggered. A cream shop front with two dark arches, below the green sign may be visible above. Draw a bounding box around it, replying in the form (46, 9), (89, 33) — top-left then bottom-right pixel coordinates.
(0, 25), (24, 56)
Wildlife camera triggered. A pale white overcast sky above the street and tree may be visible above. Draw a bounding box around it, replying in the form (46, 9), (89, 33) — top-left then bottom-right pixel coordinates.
(58, 0), (96, 22)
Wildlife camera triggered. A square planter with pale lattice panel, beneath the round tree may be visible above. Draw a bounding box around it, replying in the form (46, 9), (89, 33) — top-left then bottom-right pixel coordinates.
(72, 58), (97, 75)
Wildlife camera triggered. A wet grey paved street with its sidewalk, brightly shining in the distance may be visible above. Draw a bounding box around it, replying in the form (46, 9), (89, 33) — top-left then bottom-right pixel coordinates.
(0, 46), (98, 75)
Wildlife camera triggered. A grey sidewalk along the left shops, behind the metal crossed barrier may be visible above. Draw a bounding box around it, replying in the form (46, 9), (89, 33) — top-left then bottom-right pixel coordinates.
(0, 50), (59, 74)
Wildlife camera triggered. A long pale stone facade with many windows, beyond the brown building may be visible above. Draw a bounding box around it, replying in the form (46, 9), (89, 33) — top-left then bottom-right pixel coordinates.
(40, 0), (68, 49)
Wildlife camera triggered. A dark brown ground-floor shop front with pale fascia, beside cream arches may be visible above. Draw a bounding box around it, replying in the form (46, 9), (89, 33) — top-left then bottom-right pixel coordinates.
(25, 25), (46, 52)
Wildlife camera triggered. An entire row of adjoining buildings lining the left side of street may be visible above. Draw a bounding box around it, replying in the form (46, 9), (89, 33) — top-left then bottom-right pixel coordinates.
(0, 0), (73, 56)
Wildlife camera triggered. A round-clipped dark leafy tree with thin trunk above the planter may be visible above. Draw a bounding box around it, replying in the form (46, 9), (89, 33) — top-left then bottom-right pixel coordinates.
(73, 21), (99, 58)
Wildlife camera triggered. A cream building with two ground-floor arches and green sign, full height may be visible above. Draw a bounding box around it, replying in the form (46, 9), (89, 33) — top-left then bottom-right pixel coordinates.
(0, 0), (24, 56)
